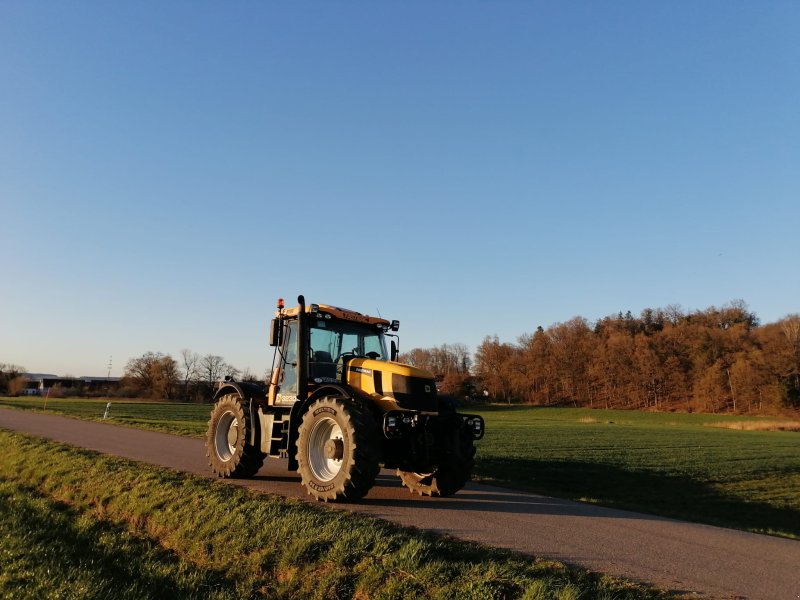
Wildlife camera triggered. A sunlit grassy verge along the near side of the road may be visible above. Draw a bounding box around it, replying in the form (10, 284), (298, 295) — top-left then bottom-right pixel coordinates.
(0, 430), (669, 600)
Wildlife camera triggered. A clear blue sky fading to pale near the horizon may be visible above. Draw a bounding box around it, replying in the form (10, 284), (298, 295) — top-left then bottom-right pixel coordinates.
(0, 0), (800, 376)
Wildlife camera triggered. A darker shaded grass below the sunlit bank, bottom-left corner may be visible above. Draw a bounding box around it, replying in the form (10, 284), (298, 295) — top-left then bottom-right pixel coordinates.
(0, 480), (235, 598)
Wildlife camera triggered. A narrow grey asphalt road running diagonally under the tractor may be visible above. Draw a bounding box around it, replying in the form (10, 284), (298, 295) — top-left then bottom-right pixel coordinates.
(0, 409), (800, 600)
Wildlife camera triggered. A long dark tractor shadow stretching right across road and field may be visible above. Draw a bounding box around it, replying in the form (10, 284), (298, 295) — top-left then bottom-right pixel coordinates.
(361, 459), (800, 536)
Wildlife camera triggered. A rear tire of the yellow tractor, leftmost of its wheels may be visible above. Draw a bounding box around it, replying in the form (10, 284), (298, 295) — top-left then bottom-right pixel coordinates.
(206, 394), (265, 478)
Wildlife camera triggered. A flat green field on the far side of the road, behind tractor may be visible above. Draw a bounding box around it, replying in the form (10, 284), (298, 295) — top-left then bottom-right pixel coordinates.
(0, 398), (800, 538)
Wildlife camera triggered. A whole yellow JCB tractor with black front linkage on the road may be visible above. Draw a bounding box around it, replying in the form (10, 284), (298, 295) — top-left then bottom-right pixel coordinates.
(206, 296), (484, 502)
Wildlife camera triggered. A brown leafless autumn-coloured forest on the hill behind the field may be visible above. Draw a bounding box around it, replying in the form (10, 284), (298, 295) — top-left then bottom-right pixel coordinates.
(401, 301), (800, 414)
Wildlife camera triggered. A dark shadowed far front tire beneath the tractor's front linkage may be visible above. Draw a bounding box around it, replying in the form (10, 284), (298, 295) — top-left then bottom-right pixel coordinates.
(397, 425), (475, 496)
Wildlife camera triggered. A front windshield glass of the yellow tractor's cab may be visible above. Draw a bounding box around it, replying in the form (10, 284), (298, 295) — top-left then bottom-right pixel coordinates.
(311, 319), (388, 362)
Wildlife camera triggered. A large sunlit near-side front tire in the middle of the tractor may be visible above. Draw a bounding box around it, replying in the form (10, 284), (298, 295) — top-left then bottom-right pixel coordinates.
(297, 397), (380, 502)
